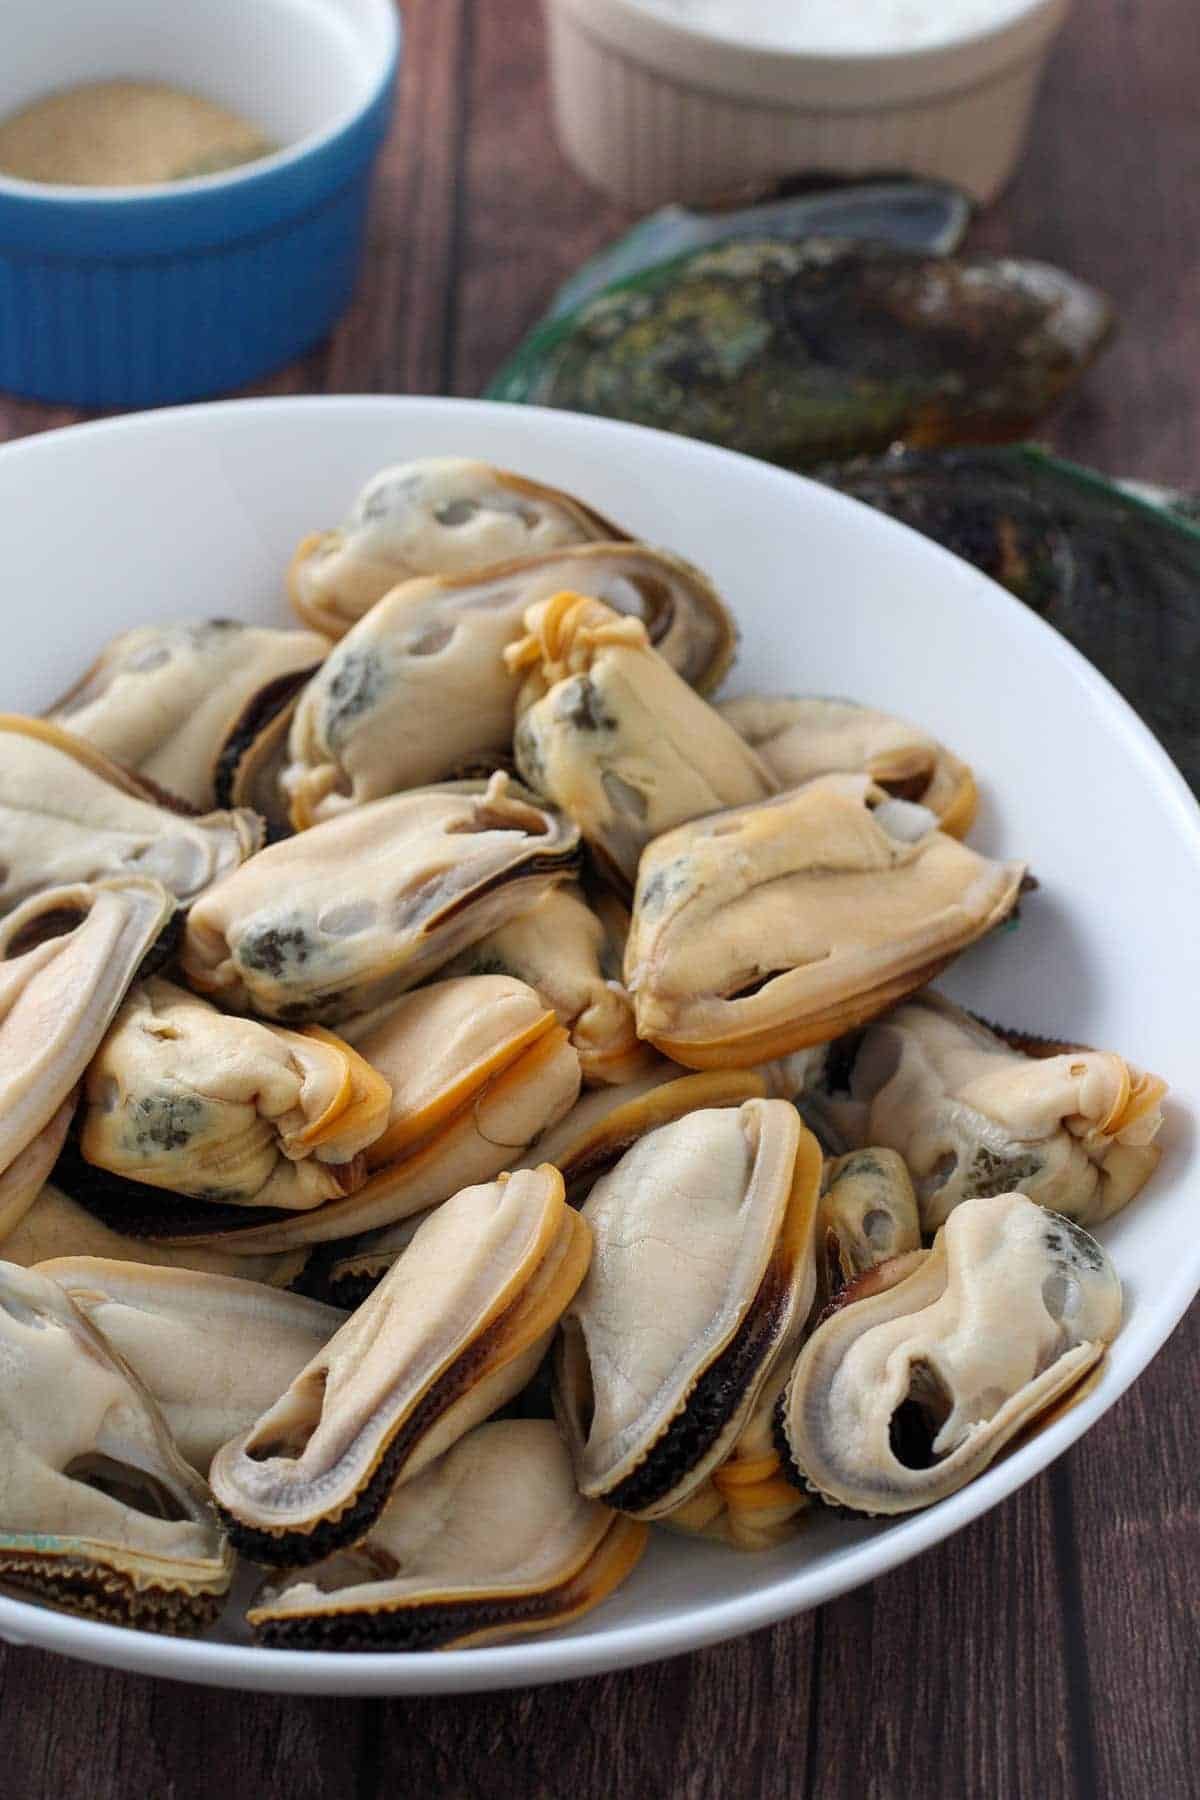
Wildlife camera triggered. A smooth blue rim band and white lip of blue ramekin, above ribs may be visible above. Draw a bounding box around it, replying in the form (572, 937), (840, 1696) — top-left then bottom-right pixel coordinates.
(0, 0), (405, 263)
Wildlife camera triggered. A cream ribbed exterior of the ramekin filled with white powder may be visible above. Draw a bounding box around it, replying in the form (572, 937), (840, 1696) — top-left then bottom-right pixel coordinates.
(543, 0), (1070, 209)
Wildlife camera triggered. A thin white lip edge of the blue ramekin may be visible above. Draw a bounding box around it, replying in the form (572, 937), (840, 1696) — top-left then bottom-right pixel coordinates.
(0, 0), (405, 207)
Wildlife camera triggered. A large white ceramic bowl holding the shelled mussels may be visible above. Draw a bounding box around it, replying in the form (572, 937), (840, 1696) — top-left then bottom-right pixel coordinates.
(0, 387), (1200, 1694)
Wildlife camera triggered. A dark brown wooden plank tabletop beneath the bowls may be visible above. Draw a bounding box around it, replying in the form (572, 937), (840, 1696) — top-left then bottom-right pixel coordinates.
(0, 0), (1200, 1800)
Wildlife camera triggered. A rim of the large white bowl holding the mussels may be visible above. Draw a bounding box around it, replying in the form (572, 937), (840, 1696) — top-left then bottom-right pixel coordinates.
(0, 394), (1200, 1696)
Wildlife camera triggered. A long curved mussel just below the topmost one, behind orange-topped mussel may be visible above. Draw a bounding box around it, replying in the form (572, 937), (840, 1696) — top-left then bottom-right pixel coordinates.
(281, 544), (736, 830)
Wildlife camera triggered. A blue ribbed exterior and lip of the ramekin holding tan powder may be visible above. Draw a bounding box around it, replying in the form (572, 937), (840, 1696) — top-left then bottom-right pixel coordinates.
(0, 0), (401, 407)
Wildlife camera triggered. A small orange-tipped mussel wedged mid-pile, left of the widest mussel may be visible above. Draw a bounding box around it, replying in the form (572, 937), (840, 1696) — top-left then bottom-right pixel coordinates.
(446, 886), (655, 1087)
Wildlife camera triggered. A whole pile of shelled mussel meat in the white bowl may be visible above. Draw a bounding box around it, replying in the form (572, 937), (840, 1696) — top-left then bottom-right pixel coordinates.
(0, 459), (1166, 1651)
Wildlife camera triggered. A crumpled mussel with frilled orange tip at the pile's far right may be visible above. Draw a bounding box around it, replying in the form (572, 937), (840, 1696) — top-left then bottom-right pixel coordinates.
(828, 994), (1166, 1233)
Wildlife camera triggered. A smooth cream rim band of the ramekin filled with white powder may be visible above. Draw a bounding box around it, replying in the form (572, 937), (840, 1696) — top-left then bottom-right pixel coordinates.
(545, 0), (1070, 112)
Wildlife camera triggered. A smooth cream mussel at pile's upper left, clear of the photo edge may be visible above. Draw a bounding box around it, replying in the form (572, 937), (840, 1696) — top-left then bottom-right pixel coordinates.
(45, 619), (329, 812)
